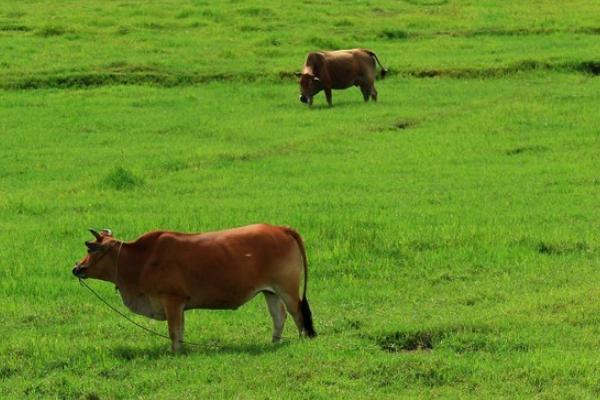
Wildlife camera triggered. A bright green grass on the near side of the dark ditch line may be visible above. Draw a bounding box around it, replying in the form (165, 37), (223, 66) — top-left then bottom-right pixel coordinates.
(0, 72), (600, 398)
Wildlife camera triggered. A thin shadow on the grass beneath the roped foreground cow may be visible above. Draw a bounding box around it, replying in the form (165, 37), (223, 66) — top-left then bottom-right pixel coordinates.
(112, 341), (289, 360)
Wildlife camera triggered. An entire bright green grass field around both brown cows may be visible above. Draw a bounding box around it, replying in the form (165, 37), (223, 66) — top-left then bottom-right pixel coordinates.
(0, 0), (600, 399)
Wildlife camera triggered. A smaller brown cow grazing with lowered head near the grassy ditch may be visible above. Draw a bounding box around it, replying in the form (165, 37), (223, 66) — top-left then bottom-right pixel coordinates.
(297, 49), (387, 106)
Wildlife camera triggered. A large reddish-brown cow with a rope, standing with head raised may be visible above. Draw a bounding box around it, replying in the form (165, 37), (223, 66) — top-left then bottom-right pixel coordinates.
(73, 224), (316, 351)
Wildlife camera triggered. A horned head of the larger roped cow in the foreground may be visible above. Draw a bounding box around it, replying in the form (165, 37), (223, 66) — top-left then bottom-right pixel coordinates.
(73, 229), (119, 280)
